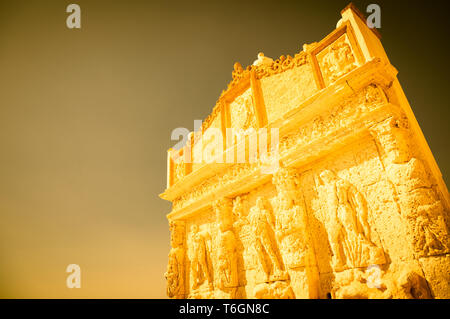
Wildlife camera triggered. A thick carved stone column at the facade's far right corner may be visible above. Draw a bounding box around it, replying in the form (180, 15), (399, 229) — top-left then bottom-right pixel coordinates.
(373, 118), (450, 257)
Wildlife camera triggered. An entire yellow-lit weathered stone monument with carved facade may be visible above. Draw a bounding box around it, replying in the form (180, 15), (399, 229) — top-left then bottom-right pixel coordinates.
(161, 6), (450, 299)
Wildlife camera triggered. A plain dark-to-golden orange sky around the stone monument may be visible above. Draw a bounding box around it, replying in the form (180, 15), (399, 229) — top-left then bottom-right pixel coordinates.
(0, 0), (450, 298)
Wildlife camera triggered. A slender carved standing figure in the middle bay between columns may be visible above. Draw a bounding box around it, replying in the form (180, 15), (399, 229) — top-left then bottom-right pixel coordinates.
(248, 197), (286, 280)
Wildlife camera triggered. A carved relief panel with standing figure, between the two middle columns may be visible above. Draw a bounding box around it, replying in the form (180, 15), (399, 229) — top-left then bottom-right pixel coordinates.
(232, 183), (295, 298)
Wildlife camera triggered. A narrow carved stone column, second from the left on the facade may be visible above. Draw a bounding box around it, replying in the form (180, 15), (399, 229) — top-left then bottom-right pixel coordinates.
(213, 198), (238, 298)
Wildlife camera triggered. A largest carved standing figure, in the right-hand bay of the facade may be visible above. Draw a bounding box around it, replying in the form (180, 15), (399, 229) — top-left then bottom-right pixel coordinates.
(320, 170), (385, 270)
